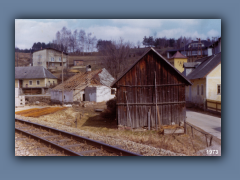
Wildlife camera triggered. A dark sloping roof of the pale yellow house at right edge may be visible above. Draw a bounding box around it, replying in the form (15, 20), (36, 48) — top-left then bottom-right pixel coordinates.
(187, 52), (221, 79)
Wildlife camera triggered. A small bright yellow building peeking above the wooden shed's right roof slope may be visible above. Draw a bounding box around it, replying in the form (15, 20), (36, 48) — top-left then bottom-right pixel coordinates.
(168, 51), (187, 73)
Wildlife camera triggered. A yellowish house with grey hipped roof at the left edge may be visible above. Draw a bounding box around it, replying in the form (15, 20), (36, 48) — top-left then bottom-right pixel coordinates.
(15, 66), (57, 94)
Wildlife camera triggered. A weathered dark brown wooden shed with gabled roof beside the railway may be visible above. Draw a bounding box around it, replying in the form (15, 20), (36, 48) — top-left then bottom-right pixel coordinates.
(112, 48), (191, 128)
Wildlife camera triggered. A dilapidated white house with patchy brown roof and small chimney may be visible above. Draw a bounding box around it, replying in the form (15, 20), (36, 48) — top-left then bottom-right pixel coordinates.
(51, 65), (115, 103)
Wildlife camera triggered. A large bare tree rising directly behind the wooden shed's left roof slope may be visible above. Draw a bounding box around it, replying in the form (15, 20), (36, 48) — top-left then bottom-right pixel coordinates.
(103, 38), (133, 78)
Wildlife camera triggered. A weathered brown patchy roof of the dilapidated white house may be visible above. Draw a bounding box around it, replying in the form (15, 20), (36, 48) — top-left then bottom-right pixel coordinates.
(53, 68), (115, 91)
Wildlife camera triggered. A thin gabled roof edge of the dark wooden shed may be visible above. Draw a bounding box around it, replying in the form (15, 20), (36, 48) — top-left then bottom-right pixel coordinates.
(111, 48), (192, 87)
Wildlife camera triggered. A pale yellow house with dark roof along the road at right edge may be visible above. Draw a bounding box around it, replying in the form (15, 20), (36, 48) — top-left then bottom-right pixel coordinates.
(183, 52), (221, 111)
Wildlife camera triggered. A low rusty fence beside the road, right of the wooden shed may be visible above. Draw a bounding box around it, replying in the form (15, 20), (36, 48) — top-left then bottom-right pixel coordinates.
(185, 122), (213, 147)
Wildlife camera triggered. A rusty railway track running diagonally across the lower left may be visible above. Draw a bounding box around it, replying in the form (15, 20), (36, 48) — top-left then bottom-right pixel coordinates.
(15, 118), (141, 156)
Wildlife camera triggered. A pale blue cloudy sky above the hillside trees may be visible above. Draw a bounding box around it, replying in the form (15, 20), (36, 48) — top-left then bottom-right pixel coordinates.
(15, 19), (221, 49)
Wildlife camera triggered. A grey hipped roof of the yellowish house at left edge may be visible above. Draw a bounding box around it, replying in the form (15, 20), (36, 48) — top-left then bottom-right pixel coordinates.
(15, 66), (57, 79)
